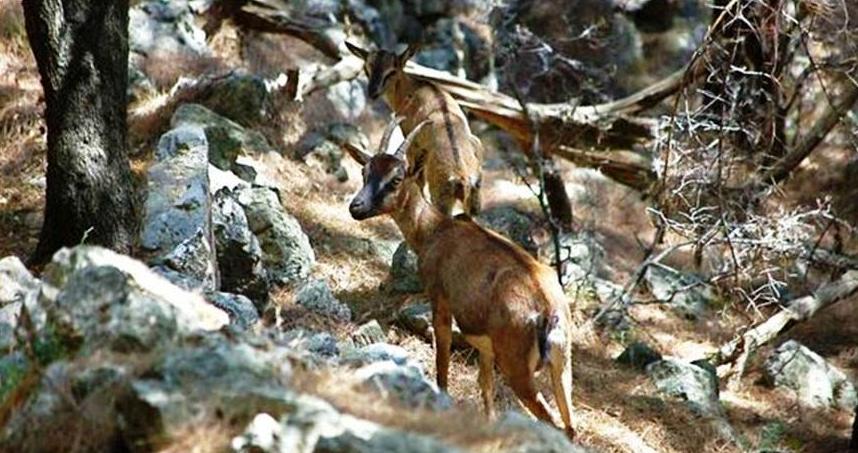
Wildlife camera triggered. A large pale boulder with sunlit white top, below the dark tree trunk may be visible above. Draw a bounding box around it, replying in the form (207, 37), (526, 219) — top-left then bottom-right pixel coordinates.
(42, 245), (229, 334)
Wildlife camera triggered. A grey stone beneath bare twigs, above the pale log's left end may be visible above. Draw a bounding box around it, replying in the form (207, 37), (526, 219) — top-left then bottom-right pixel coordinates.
(644, 264), (715, 320)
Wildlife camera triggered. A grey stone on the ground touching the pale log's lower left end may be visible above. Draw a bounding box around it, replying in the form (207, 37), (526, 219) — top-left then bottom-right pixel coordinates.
(646, 358), (724, 418)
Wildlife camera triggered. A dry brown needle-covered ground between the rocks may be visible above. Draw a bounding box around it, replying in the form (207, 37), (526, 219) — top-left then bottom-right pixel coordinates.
(0, 5), (858, 452)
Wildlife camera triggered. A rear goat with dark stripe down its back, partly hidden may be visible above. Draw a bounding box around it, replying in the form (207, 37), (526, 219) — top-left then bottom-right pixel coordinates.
(346, 42), (483, 216)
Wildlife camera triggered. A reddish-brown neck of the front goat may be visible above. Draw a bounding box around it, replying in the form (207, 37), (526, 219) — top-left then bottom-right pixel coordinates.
(392, 183), (444, 254)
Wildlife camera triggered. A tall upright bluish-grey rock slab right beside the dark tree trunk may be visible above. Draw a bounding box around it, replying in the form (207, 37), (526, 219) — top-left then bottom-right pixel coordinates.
(140, 126), (218, 291)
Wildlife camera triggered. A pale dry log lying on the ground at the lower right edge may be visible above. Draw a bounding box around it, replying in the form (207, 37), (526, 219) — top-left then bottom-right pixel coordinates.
(713, 271), (858, 384)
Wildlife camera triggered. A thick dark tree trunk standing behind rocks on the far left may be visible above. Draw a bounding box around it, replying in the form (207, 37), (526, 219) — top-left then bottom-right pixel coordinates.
(23, 0), (136, 263)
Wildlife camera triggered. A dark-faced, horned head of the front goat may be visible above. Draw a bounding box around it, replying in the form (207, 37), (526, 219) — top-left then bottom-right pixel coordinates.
(346, 118), (429, 220)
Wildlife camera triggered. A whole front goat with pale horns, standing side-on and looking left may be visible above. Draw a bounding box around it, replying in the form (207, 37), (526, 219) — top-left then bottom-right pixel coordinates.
(347, 120), (574, 437)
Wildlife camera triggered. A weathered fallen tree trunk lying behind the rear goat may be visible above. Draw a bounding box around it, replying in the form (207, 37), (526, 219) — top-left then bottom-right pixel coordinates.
(221, 0), (701, 192)
